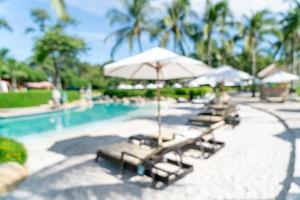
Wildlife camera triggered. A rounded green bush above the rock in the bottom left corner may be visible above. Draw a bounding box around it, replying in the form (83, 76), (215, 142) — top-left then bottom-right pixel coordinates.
(0, 137), (27, 165)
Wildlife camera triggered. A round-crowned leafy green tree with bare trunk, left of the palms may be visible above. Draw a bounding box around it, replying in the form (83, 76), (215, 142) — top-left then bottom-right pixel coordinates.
(34, 28), (86, 88)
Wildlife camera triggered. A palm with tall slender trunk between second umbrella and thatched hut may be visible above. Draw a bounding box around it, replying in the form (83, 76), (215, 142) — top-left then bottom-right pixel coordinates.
(243, 10), (274, 97)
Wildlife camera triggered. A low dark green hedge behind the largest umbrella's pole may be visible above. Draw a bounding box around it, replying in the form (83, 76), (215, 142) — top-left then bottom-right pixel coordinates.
(103, 87), (212, 98)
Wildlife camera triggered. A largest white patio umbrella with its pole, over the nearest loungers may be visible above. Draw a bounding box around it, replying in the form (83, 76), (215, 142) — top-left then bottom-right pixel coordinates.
(104, 47), (212, 144)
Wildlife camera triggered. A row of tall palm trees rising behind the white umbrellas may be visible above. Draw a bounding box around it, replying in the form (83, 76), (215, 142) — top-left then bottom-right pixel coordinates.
(109, 0), (300, 75)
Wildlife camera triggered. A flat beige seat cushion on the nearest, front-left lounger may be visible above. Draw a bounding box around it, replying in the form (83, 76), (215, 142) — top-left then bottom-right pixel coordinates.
(99, 141), (157, 165)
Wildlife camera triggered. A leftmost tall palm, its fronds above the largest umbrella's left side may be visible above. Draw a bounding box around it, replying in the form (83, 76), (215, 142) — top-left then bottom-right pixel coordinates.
(106, 0), (149, 58)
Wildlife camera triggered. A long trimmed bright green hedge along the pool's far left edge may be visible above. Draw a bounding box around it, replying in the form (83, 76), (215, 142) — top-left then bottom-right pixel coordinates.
(0, 90), (80, 108)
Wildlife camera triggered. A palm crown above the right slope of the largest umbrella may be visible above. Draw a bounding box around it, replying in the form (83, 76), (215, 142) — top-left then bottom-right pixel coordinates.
(152, 0), (194, 54)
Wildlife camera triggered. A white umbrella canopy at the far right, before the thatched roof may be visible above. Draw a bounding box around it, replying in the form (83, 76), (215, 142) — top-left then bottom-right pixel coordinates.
(262, 71), (299, 83)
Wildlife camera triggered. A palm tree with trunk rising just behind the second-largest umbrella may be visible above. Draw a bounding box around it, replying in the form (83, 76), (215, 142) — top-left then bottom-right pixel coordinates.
(203, 0), (231, 65)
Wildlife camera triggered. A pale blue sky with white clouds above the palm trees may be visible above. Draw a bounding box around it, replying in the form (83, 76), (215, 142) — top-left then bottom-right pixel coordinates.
(0, 0), (288, 64)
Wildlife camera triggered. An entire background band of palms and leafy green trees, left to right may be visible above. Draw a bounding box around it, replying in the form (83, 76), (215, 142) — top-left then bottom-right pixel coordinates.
(0, 0), (300, 93)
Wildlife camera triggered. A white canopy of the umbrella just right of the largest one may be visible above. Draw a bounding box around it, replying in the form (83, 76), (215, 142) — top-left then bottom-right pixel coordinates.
(208, 65), (252, 83)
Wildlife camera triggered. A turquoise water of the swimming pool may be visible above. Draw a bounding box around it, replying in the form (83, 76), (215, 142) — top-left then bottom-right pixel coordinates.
(0, 104), (138, 138)
